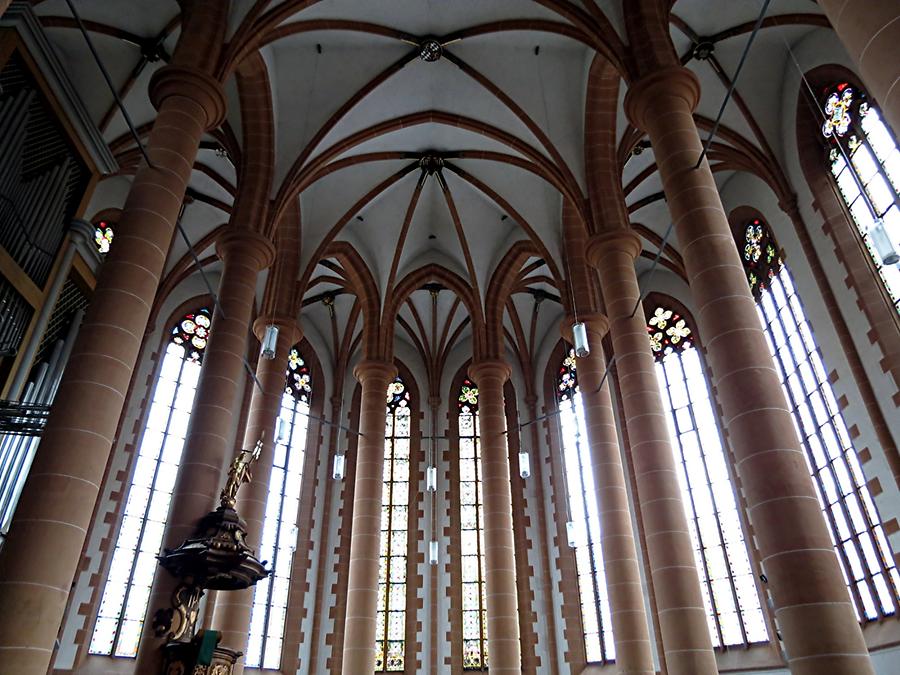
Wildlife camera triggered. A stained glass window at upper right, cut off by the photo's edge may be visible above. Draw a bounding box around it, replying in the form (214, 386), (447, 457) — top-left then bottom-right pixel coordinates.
(822, 82), (900, 311)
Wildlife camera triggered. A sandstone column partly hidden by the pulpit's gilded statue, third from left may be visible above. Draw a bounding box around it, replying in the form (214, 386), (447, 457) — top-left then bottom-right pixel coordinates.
(212, 316), (300, 675)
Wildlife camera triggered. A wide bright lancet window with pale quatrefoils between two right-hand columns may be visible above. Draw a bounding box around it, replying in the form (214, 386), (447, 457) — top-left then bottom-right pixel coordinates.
(647, 306), (768, 647)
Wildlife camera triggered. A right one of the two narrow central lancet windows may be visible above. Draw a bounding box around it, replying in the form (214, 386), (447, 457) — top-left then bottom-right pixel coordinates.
(457, 378), (488, 670)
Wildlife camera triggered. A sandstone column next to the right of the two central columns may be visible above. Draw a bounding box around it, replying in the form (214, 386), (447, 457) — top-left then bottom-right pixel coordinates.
(562, 313), (656, 675)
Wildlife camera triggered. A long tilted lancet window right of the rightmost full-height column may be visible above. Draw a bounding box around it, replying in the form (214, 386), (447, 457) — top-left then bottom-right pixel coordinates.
(742, 218), (900, 620)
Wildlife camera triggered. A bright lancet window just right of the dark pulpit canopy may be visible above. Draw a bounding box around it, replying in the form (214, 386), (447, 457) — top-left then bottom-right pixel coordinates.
(246, 347), (312, 670)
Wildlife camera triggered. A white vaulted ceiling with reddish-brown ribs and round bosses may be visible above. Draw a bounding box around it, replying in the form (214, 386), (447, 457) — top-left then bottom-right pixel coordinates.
(32, 0), (829, 390)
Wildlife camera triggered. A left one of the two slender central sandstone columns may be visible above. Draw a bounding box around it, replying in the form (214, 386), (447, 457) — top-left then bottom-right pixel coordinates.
(343, 360), (397, 675)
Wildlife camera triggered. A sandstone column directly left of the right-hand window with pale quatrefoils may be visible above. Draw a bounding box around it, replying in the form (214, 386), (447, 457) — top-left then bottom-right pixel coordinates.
(579, 230), (718, 675)
